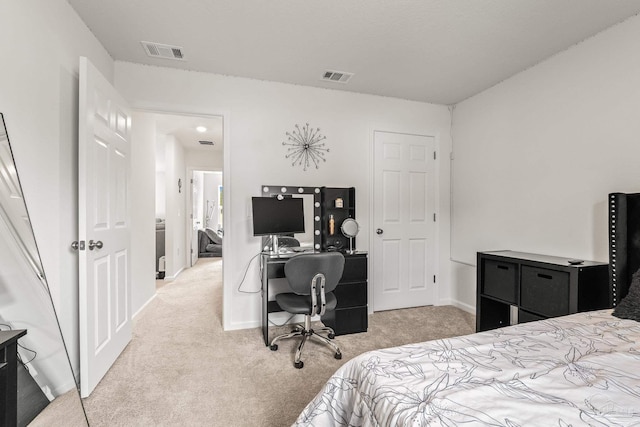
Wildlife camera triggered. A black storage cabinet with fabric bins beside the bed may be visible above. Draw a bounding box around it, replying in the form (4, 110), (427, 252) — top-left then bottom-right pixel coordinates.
(476, 251), (611, 332)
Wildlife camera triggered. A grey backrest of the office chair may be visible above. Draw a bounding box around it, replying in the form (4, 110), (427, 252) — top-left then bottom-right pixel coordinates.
(284, 252), (344, 295)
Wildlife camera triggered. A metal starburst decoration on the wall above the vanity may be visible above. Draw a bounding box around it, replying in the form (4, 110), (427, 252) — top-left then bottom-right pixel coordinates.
(282, 123), (329, 171)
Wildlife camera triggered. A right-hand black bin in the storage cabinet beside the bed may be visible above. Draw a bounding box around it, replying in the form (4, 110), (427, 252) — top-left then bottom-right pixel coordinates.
(520, 265), (569, 317)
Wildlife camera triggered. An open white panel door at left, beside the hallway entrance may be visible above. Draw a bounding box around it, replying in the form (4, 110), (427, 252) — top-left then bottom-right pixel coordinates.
(78, 57), (131, 397)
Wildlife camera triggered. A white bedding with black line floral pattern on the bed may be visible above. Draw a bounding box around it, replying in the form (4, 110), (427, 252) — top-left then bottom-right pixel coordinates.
(294, 310), (640, 427)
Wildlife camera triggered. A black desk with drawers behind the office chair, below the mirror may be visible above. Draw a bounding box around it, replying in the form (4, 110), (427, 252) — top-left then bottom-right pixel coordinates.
(260, 251), (368, 346)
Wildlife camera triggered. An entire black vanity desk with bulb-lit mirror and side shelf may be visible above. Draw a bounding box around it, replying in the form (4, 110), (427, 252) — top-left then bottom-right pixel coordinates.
(252, 185), (368, 346)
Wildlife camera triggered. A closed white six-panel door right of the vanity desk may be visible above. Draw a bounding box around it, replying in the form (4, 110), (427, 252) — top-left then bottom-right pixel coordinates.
(373, 132), (435, 311)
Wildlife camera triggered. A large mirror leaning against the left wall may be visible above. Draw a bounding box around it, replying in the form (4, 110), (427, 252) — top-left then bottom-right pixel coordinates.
(0, 113), (88, 426)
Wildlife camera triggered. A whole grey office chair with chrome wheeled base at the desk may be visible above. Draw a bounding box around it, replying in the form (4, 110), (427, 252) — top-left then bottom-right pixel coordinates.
(270, 252), (344, 369)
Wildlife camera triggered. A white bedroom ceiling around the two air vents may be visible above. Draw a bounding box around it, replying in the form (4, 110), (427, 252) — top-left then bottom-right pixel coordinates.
(68, 0), (640, 105)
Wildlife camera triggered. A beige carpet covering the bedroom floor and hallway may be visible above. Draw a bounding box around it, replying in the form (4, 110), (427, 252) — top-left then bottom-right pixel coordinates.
(63, 259), (475, 427)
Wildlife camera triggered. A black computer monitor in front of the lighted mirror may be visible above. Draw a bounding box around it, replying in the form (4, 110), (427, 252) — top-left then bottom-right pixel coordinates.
(251, 197), (304, 236)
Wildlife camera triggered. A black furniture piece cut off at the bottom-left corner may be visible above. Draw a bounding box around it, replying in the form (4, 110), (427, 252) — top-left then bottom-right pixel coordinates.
(0, 329), (27, 427)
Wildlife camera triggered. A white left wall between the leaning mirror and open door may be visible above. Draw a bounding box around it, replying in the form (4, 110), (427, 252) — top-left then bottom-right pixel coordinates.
(0, 0), (113, 392)
